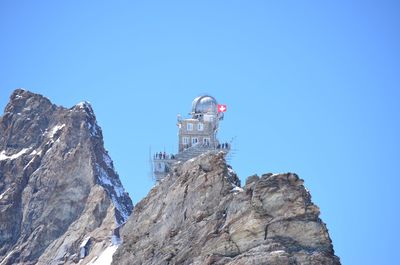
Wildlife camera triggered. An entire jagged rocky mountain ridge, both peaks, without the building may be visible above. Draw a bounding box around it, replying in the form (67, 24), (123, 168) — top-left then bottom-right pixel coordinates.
(0, 89), (340, 265)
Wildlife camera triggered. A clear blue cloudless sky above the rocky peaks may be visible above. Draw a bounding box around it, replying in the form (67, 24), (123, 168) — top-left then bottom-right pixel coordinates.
(0, 0), (400, 265)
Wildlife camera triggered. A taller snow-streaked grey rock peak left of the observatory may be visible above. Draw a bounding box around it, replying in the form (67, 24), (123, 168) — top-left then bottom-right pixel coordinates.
(0, 89), (133, 265)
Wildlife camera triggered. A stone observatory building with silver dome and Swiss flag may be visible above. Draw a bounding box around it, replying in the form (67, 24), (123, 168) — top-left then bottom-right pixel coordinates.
(152, 95), (231, 180)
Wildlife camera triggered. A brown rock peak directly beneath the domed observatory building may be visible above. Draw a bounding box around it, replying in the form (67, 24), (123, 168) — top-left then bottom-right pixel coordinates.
(113, 154), (340, 265)
